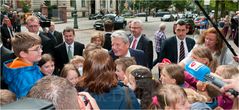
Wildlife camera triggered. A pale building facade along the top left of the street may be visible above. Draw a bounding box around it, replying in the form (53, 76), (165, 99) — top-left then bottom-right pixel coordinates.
(1, 0), (117, 17)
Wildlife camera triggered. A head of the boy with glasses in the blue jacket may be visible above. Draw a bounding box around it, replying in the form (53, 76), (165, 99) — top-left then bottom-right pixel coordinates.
(11, 32), (42, 62)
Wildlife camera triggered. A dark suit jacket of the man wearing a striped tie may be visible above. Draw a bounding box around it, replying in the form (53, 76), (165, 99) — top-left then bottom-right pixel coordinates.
(158, 36), (195, 63)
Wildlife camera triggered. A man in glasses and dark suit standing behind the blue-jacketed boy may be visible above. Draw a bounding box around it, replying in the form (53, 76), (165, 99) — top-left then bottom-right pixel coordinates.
(26, 16), (54, 54)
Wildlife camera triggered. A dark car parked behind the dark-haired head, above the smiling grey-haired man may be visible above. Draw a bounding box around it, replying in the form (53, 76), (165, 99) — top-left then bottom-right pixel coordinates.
(93, 14), (127, 30)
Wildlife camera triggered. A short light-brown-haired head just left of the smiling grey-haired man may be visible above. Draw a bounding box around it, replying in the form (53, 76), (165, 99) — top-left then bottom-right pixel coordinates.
(90, 32), (104, 46)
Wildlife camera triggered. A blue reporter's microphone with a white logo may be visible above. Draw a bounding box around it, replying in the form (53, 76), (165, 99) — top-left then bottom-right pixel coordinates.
(185, 61), (239, 97)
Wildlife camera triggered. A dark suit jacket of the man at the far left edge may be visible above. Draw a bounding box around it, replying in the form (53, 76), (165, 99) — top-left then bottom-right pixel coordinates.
(1, 24), (13, 50)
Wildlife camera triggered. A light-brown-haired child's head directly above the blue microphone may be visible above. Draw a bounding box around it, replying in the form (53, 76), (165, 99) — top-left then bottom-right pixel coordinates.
(191, 46), (218, 72)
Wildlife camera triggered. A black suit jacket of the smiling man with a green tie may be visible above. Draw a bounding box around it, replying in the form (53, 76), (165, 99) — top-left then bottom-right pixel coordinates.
(54, 42), (85, 73)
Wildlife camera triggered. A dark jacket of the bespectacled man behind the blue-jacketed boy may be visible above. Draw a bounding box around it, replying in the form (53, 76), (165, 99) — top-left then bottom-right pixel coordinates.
(39, 32), (54, 54)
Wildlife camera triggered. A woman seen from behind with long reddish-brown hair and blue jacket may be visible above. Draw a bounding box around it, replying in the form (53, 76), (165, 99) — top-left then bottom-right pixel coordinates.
(76, 49), (140, 109)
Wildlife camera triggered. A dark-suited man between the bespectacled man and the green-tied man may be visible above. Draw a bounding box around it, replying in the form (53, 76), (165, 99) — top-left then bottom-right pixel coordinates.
(48, 22), (63, 46)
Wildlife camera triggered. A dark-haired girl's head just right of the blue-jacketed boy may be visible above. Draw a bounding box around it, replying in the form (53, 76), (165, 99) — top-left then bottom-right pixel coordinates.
(38, 54), (55, 76)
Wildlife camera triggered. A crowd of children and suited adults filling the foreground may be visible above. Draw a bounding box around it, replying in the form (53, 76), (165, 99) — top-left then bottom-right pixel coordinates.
(0, 10), (239, 110)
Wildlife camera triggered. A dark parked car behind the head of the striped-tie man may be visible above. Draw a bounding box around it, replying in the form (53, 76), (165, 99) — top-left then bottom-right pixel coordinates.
(173, 19), (195, 35)
